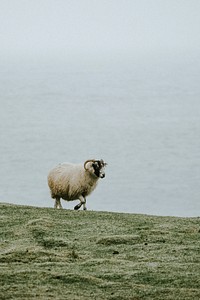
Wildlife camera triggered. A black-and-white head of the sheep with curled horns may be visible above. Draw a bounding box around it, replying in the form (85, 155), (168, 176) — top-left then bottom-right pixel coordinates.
(84, 159), (107, 178)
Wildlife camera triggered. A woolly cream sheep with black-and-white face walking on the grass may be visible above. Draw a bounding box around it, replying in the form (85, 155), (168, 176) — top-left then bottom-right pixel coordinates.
(48, 159), (107, 210)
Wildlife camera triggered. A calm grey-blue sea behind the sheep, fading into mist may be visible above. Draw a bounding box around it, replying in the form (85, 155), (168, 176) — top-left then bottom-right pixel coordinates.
(0, 56), (200, 216)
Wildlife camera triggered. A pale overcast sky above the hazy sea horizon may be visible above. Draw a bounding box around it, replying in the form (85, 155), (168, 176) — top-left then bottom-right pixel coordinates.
(0, 0), (200, 59)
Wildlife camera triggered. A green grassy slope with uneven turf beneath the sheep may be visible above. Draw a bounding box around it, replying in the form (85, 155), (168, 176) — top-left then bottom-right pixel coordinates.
(0, 204), (200, 300)
